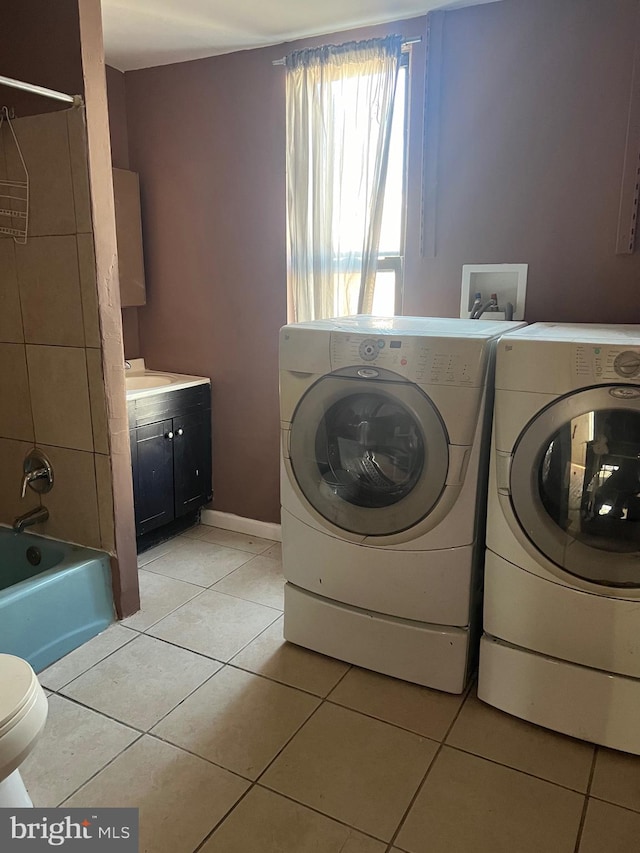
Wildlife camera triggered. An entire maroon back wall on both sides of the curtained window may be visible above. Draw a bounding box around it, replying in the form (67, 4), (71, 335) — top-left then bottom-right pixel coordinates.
(126, 0), (640, 521)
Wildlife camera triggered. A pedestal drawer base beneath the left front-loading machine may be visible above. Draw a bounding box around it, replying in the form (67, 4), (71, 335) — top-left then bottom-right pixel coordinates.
(284, 583), (470, 693)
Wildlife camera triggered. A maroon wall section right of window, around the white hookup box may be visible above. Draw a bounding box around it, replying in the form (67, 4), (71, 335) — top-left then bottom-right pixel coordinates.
(405, 0), (640, 323)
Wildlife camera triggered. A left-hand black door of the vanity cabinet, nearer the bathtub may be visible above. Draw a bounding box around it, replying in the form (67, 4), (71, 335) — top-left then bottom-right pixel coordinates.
(132, 420), (174, 536)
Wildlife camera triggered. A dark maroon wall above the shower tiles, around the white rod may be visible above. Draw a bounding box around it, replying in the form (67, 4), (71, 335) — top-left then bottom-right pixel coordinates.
(0, 0), (84, 116)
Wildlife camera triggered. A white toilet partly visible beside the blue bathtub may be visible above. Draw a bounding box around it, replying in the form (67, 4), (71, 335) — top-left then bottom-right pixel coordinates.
(0, 654), (48, 808)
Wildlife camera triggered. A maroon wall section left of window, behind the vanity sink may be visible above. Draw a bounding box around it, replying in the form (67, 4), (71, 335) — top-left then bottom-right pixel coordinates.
(126, 19), (424, 521)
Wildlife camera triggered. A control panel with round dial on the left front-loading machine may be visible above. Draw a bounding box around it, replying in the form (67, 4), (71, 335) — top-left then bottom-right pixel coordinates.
(331, 332), (488, 387)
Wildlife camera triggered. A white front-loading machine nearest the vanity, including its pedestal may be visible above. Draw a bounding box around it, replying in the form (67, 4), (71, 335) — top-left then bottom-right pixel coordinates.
(280, 316), (522, 693)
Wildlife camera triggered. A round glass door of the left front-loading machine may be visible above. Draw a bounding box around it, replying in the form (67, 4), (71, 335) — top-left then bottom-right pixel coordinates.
(290, 371), (449, 536)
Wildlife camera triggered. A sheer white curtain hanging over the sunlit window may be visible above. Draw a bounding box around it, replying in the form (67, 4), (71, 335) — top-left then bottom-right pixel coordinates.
(285, 36), (402, 322)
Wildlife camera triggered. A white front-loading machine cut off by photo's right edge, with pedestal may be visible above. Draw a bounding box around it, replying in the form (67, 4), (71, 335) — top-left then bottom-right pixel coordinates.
(478, 323), (640, 754)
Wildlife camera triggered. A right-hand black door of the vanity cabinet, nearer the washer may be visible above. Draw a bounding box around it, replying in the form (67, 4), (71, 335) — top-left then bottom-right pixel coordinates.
(173, 410), (211, 518)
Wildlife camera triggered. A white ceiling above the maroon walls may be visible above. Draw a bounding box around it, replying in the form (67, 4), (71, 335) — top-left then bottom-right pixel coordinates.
(102, 0), (496, 71)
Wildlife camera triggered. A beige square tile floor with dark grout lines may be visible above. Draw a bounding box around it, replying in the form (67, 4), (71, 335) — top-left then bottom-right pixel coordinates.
(23, 527), (640, 853)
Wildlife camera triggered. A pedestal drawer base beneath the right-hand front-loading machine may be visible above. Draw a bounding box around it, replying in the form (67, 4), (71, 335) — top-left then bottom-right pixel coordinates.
(478, 634), (640, 755)
